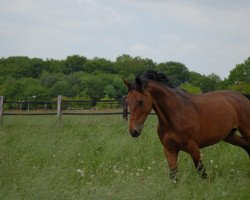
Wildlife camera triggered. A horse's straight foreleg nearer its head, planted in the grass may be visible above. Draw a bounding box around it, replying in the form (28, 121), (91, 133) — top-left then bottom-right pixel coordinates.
(164, 148), (179, 181)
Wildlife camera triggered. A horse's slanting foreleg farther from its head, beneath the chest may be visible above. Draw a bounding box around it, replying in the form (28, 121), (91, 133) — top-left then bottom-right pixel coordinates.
(187, 143), (207, 179)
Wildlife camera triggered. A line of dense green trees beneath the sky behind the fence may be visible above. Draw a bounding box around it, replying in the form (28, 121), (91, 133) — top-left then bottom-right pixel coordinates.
(0, 55), (250, 101)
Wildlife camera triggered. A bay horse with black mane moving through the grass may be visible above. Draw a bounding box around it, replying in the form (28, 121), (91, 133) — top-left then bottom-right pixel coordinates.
(123, 71), (250, 180)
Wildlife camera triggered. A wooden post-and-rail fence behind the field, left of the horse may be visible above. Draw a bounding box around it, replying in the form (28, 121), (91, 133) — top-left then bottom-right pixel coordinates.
(0, 95), (128, 125)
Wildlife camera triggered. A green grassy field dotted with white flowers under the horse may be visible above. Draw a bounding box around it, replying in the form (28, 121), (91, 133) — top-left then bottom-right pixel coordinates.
(0, 116), (250, 200)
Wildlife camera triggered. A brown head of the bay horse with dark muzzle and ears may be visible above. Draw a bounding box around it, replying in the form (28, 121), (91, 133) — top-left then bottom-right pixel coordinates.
(124, 77), (152, 137)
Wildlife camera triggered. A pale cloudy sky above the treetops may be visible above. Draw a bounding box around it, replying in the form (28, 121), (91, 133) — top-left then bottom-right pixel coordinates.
(0, 0), (250, 78)
